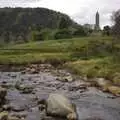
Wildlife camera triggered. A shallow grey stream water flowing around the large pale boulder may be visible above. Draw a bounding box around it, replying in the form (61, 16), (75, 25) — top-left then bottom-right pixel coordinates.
(0, 72), (120, 120)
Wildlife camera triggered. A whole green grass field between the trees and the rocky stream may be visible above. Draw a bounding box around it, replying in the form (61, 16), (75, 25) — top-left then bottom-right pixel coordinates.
(0, 37), (120, 85)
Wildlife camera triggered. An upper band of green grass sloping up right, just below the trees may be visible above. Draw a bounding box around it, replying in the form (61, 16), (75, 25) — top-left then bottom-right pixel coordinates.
(5, 37), (112, 52)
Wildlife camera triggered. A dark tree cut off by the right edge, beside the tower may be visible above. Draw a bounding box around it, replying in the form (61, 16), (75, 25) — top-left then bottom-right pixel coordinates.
(112, 9), (120, 38)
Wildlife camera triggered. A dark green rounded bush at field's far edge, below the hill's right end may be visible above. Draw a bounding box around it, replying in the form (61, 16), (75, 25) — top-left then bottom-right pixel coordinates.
(54, 29), (72, 39)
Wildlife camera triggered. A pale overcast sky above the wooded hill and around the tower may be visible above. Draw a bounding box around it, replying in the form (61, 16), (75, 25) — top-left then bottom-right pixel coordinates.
(0, 0), (120, 26)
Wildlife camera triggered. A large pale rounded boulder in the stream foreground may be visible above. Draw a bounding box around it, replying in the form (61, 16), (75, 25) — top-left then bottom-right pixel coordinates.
(46, 94), (77, 120)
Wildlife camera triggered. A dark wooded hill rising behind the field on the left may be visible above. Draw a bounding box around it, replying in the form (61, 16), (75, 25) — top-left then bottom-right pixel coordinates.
(0, 8), (77, 42)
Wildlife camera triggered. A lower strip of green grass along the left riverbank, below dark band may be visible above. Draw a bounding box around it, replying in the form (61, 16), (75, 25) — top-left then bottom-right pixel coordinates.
(0, 53), (70, 65)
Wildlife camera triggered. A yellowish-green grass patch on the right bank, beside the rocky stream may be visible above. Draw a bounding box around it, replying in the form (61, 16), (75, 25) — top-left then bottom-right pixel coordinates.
(65, 57), (120, 80)
